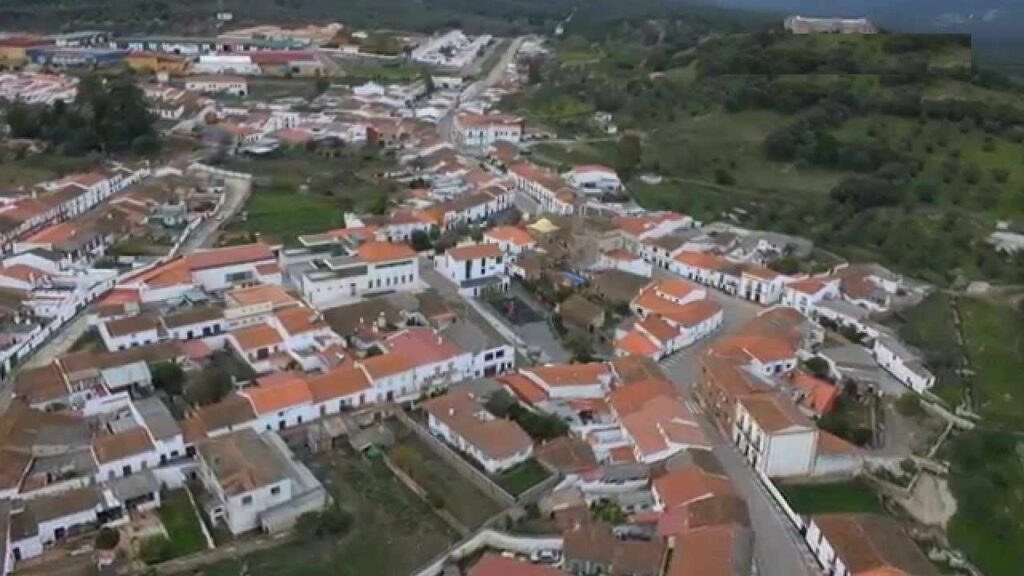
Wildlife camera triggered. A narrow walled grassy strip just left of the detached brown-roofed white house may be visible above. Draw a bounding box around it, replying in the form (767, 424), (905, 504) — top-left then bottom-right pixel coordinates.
(388, 424), (501, 529)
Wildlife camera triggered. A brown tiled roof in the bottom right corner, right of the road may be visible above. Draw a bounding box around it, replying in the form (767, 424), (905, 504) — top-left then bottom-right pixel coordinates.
(812, 513), (938, 576)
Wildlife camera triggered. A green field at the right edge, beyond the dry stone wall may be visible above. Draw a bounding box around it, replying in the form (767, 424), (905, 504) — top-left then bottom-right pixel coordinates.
(959, 298), (1024, 430)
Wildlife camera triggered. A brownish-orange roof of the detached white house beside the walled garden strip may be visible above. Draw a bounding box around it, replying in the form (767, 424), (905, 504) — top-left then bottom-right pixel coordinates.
(423, 390), (534, 460)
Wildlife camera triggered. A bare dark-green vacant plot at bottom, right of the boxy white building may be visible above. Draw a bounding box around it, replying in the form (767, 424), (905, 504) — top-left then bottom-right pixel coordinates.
(194, 450), (456, 576)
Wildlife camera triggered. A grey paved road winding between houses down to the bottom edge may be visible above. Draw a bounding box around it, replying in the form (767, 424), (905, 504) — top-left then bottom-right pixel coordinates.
(657, 273), (818, 576)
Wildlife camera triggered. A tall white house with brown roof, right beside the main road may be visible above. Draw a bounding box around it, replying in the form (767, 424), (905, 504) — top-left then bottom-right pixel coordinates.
(732, 393), (818, 478)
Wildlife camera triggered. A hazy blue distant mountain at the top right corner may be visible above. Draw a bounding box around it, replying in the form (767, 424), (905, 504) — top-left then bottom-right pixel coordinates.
(677, 0), (1024, 40)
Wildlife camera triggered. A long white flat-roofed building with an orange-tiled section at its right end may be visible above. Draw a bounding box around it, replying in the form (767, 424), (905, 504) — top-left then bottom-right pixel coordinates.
(301, 242), (420, 307)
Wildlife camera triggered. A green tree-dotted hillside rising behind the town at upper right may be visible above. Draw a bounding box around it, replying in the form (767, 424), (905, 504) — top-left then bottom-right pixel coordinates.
(509, 26), (1024, 285)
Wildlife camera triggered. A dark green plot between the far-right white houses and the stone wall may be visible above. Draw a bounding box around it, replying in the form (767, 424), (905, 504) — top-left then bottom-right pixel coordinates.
(889, 292), (965, 408)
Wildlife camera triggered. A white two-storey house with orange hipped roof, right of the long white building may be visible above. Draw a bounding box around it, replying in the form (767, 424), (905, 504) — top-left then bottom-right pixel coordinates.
(436, 244), (509, 296)
